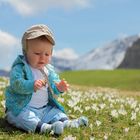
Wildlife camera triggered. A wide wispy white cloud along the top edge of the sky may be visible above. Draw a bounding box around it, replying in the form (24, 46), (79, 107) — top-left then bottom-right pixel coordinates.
(3, 0), (91, 16)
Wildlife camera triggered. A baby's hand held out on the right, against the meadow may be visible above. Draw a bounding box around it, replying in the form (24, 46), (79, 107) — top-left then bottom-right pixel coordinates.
(56, 80), (69, 92)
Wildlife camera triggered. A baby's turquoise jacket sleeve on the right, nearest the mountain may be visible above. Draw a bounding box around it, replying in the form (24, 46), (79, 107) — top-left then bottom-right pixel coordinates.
(47, 65), (63, 95)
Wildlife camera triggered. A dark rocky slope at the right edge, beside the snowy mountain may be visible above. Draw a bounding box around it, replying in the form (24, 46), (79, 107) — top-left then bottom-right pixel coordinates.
(118, 39), (140, 69)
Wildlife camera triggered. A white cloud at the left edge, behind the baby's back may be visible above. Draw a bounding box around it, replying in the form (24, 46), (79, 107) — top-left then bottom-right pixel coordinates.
(0, 30), (20, 69)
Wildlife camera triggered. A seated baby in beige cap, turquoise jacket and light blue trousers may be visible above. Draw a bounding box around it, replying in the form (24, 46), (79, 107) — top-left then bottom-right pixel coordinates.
(5, 24), (88, 135)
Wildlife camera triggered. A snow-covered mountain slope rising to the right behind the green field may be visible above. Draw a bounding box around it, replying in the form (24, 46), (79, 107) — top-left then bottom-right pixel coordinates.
(53, 35), (140, 71)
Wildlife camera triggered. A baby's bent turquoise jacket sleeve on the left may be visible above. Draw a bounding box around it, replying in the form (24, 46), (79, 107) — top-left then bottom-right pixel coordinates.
(10, 65), (34, 94)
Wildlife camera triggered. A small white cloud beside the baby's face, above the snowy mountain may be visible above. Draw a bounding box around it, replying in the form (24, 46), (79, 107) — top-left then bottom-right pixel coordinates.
(53, 48), (78, 59)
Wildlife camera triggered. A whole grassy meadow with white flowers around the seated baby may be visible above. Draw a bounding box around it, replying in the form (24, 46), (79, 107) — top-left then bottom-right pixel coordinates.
(0, 70), (140, 140)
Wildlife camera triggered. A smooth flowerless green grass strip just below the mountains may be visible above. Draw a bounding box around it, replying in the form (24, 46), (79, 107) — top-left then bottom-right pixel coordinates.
(60, 69), (140, 91)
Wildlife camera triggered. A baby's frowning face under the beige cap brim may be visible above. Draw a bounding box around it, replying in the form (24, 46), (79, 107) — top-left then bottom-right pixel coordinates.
(26, 39), (53, 69)
